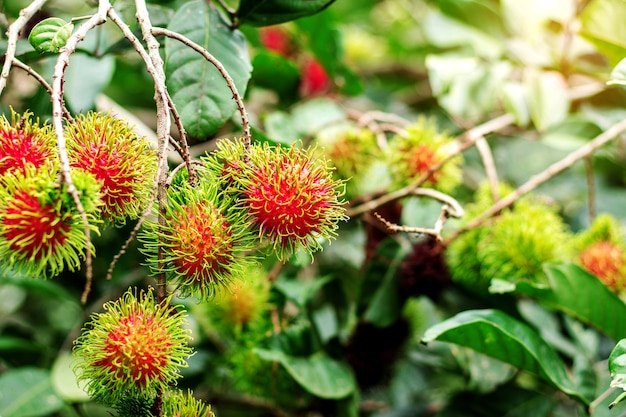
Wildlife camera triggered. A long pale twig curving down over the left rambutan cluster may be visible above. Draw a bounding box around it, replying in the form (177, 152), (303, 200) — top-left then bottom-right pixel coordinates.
(50, 0), (111, 304)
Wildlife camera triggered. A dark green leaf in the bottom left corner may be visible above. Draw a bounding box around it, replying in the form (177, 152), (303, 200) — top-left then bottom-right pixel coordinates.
(0, 368), (63, 417)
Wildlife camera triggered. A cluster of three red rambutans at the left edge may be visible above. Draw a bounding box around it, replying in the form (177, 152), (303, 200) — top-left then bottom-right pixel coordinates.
(0, 112), (156, 277)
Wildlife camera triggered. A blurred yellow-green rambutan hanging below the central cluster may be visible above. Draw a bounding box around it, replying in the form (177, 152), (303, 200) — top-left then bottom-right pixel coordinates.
(215, 265), (270, 329)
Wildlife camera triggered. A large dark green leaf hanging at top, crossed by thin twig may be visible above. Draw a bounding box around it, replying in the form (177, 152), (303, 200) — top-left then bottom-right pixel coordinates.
(165, 0), (252, 138)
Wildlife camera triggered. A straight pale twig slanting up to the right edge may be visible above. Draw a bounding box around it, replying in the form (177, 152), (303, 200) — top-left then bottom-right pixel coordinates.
(449, 119), (626, 240)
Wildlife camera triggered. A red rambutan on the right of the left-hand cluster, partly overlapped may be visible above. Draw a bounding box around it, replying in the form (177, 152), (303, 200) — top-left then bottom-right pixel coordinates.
(65, 112), (157, 224)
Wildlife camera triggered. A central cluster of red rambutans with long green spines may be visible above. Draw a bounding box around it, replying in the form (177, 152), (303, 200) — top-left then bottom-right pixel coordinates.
(140, 140), (346, 299)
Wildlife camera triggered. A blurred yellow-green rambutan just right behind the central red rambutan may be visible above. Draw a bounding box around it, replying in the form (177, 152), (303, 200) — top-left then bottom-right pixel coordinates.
(316, 128), (382, 196)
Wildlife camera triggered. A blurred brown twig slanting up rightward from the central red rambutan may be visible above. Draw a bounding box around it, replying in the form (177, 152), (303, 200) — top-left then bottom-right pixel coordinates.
(346, 114), (515, 217)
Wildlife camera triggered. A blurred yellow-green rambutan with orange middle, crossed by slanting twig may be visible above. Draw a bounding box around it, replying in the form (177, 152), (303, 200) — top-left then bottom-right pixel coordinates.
(387, 118), (462, 192)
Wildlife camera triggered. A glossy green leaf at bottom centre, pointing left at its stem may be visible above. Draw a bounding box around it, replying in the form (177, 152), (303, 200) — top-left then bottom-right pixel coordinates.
(254, 348), (356, 399)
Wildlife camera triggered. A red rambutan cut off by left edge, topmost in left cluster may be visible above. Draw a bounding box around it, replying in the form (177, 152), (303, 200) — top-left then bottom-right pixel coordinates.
(0, 111), (56, 175)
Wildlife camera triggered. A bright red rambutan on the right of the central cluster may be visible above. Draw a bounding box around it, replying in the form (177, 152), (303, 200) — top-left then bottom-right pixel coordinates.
(240, 144), (347, 260)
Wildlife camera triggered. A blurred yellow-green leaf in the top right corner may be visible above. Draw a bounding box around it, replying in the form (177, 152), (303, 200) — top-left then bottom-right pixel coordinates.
(579, 0), (626, 66)
